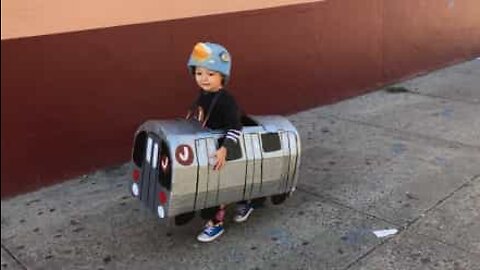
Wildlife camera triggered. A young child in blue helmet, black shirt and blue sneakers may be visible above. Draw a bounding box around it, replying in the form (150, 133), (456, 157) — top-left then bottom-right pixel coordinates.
(187, 42), (253, 242)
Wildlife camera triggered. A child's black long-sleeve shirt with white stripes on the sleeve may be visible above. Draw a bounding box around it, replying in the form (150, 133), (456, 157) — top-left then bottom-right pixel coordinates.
(194, 89), (242, 152)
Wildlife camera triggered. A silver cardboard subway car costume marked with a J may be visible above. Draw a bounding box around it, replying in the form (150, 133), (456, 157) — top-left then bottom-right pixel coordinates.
(130, 116), (301, 225)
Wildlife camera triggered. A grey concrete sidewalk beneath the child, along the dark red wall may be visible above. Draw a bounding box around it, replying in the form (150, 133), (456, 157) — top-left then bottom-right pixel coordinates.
(1, 59), (480, 270)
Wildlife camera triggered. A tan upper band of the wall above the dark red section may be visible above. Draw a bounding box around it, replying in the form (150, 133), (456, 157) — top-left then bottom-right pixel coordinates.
(2, 0), (322, 39)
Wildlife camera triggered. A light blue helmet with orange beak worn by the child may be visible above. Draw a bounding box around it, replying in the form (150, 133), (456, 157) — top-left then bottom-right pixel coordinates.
(187, 42), (232, 83)
